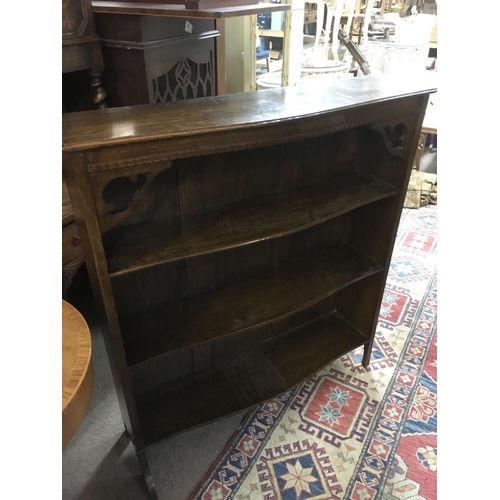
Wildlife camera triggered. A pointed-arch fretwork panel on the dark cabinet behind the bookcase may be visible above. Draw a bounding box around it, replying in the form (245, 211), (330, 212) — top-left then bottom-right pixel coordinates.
(152, 58), (215, 102)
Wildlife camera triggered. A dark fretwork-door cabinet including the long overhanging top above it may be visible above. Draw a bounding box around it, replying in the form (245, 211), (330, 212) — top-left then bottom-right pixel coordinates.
(92, 1), (290, 106)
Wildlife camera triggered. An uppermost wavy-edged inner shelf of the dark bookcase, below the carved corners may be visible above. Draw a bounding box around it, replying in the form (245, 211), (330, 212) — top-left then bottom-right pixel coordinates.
(104, 172), (398, 276)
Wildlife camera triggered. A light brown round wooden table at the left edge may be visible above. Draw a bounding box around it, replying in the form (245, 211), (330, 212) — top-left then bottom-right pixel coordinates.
(62, 300), (94, 449)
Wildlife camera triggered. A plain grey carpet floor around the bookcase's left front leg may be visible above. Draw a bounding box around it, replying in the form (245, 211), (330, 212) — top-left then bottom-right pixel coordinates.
(62, 146), (437, 500)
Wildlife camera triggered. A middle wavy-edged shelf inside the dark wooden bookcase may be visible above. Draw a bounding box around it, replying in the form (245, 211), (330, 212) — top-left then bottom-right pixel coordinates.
(121, 246), (382, 366)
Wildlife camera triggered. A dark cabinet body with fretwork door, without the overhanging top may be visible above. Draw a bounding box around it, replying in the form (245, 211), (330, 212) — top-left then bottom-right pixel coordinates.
(96, 13), (219, 106)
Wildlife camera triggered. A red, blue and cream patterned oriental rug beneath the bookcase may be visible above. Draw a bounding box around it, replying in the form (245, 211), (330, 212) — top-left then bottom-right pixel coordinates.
(190, 205), (437, 500)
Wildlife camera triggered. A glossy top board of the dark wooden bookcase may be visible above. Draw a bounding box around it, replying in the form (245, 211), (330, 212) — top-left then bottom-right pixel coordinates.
(62, 72), (437, 152)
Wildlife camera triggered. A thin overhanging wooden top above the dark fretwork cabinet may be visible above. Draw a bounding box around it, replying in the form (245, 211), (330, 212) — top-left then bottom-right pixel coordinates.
(92, 0), (291, 19)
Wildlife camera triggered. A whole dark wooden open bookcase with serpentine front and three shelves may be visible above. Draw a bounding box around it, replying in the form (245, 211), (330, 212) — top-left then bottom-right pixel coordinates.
(62, 74), (435, 498)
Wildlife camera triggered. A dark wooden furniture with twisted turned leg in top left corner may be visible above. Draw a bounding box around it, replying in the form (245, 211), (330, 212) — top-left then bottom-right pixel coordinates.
(62, 0), (106, 108)
